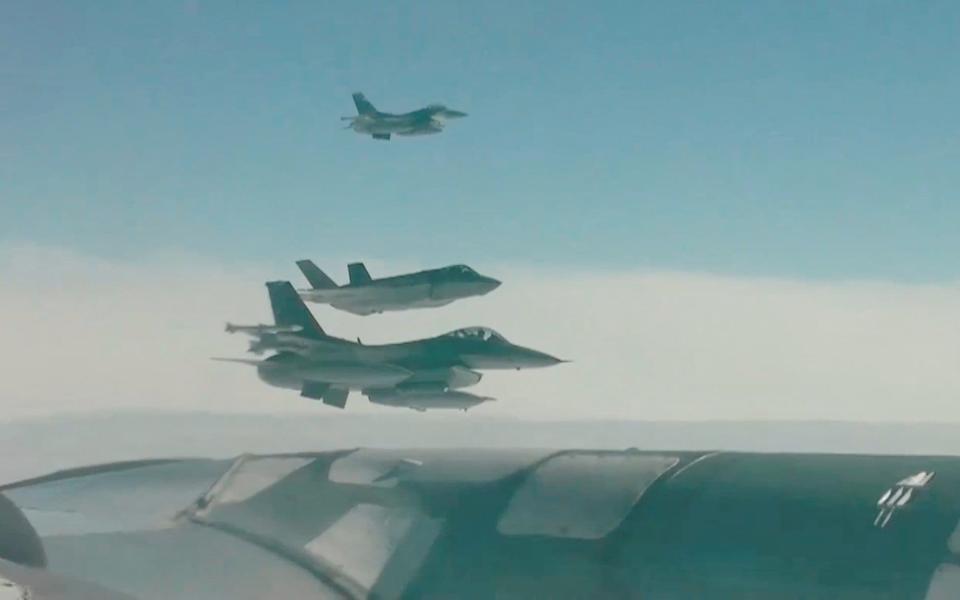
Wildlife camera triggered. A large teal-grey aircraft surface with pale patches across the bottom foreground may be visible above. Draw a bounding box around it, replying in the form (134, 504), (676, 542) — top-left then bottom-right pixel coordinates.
(0, 448), (960, 600)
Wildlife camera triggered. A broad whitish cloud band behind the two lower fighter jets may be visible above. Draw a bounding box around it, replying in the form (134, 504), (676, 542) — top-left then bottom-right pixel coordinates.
(0, 245), (960, 421)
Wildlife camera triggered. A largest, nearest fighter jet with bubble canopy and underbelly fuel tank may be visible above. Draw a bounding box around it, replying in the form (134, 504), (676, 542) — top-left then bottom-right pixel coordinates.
(219, 281), (564, 410)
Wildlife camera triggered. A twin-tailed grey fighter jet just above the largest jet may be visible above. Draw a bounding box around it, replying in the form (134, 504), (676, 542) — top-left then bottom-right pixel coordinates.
(297, 260), (500, 315)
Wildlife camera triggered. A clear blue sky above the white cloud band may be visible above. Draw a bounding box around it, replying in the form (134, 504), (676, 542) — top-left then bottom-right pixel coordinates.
(0, 0), (960, 281)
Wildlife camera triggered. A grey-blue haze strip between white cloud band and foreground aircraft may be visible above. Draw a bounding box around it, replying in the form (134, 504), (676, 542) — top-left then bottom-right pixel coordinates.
(9, 411), (960, 484)
